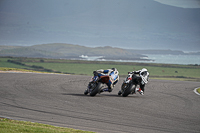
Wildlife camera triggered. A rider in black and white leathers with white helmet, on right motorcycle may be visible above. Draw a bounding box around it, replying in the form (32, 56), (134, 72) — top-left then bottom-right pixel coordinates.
(130, 68), (149, 95)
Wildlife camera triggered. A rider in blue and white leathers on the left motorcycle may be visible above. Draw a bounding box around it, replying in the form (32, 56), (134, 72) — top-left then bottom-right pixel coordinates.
(93, 68), (119, 92)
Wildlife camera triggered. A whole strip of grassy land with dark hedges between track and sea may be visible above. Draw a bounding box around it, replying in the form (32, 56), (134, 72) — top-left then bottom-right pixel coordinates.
(0, 58), (200, 81)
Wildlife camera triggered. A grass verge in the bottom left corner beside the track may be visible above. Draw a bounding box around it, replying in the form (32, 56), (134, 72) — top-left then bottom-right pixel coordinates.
(0, 118), (94, 133)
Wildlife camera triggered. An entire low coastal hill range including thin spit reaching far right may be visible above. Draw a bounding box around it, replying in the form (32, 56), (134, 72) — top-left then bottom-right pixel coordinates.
(0, 43), (200, 60)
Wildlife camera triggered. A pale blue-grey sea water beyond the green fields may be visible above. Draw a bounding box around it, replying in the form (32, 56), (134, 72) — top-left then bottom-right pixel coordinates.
(80, 54), (200, 65)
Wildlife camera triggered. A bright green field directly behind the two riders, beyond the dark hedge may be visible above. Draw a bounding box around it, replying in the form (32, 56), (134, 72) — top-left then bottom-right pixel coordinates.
(23, 62), (200, 78)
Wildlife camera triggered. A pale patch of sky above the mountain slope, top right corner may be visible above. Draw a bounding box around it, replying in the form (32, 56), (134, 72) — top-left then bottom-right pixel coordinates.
(154, 0), (200, 8)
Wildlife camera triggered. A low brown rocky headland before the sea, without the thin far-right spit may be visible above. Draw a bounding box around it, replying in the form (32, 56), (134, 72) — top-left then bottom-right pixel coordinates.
(0, 43), (146, 60)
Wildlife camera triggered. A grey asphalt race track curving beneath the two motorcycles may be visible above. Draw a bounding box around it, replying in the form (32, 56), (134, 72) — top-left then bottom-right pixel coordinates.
(0, 73), (200, 133)
